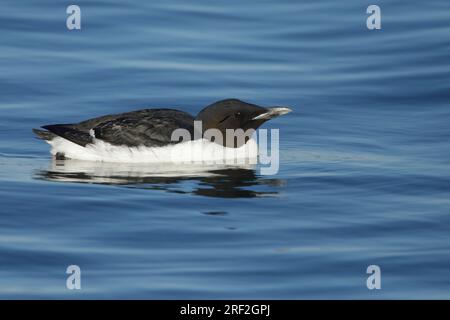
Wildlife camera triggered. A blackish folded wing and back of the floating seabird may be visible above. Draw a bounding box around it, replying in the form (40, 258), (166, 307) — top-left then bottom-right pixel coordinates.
(43, 109), (194, 147)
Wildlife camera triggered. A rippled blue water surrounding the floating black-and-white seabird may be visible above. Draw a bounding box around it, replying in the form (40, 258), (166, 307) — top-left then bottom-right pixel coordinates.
(0, 0), (450, 299)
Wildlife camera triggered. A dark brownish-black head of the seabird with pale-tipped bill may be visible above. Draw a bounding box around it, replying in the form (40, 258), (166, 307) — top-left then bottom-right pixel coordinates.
(195, 99), (292, 148)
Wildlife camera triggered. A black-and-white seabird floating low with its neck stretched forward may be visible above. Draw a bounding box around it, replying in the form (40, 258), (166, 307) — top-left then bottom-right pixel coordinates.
(33, 99), (292, 162)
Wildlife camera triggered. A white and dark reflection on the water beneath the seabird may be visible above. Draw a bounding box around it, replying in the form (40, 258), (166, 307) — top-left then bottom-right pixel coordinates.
(35, 159), (285, 198)
